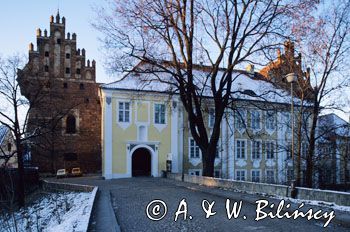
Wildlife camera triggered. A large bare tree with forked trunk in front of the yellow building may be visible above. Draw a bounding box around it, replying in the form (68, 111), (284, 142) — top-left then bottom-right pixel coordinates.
(94, 0), (312, 176)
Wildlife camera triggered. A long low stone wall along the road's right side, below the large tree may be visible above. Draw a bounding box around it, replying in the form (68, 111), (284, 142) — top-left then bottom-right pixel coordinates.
(167, 173), (350, 206)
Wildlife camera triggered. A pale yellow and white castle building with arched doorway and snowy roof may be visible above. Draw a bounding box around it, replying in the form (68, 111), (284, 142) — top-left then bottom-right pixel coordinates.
(101, 46), (312, 183)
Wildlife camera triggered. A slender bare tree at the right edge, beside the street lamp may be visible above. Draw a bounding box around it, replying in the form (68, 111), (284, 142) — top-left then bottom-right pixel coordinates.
(294, 0), (350, 187)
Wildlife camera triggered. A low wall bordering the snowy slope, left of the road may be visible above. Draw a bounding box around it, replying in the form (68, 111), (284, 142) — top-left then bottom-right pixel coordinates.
(43, 180), (98, 232)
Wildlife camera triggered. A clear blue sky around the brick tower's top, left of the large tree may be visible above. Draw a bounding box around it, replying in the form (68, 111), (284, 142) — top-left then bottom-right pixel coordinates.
(0, 0), (113, 82)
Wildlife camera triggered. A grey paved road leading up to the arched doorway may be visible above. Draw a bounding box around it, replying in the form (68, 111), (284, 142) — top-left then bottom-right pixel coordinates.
(52, 178), (350, 232)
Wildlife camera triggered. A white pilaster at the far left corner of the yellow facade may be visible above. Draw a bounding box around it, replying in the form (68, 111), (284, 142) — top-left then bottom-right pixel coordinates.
(103, 96), (113, 179)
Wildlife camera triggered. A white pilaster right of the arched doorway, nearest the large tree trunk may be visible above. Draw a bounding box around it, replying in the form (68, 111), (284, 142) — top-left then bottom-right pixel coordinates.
(171, 100), (179, 173)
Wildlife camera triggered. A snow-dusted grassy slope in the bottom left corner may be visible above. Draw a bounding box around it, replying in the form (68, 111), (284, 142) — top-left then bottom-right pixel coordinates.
(0, 192), (92, 232)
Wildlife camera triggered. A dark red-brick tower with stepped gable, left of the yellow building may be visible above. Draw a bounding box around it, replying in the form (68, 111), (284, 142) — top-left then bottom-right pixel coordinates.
(18, 12), (101, 172)
